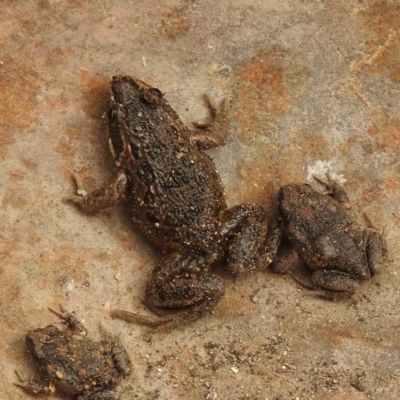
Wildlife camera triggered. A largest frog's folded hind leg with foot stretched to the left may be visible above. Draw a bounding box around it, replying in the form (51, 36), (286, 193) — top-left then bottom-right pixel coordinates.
(112, 253), (224, 329)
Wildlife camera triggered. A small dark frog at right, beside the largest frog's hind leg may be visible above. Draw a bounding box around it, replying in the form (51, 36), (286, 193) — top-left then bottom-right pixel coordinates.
(268, 179), (386, 299)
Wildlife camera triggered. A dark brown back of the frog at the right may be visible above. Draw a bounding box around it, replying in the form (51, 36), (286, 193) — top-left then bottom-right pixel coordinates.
(279, 184), (363, 271)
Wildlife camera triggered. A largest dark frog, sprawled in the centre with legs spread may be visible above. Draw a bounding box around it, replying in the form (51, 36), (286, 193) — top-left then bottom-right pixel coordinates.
(66, 76), (267, 328)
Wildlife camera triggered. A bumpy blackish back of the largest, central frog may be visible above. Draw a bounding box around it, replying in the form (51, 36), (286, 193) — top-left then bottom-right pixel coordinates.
(110, 76), (225, 252)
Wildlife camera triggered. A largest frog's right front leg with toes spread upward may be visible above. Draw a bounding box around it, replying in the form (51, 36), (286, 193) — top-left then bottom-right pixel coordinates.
(189, 94), (229, 150)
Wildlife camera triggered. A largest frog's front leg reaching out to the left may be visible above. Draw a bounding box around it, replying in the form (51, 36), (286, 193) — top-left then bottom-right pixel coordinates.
(63, 170), (128, 213)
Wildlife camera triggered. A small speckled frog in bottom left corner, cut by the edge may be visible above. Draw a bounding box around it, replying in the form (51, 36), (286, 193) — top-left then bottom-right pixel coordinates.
(15, 310), (131, 400)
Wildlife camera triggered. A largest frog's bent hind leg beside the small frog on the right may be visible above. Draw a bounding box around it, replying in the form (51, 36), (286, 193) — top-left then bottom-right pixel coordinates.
(221, 204), (268, 276)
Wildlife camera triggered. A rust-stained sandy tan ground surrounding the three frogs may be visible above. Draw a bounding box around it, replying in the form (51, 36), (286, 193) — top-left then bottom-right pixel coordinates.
(0, 0), (400, 400)
